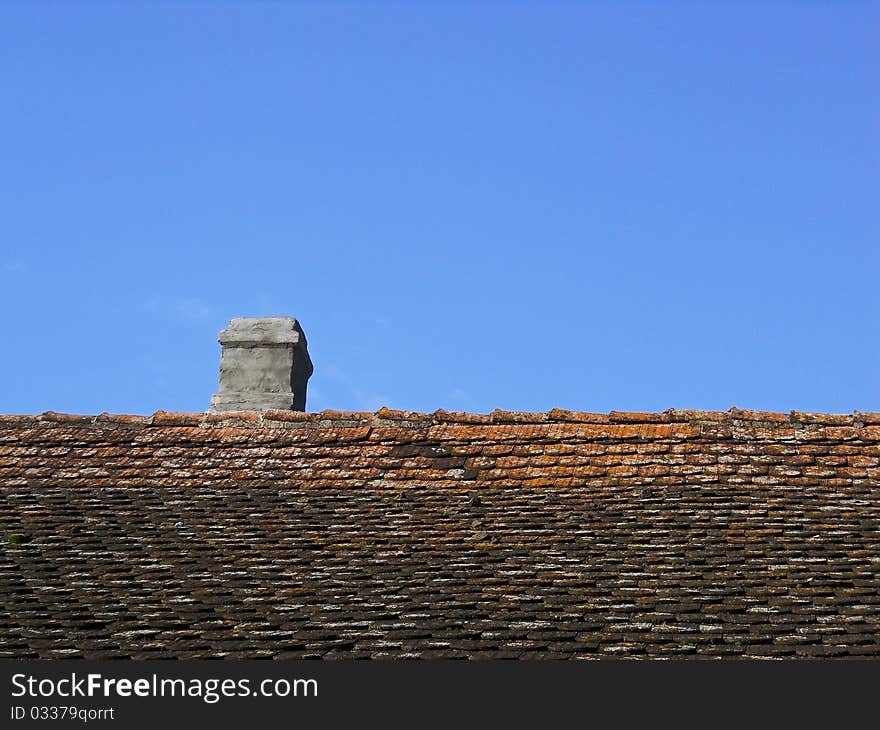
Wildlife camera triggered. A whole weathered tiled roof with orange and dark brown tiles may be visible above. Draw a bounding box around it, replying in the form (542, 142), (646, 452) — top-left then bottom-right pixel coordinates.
(0, 409), (880, 658)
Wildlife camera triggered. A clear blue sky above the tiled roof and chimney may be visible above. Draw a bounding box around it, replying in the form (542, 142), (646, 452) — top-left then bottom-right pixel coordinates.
(0, 0), (880, 413)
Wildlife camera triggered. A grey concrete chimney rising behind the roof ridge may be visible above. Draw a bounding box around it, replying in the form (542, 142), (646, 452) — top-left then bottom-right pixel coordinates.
(211, 317), (312, 413)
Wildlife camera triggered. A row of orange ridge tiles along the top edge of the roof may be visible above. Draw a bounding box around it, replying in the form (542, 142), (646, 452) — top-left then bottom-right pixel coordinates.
(0, 407), (880, 428)
